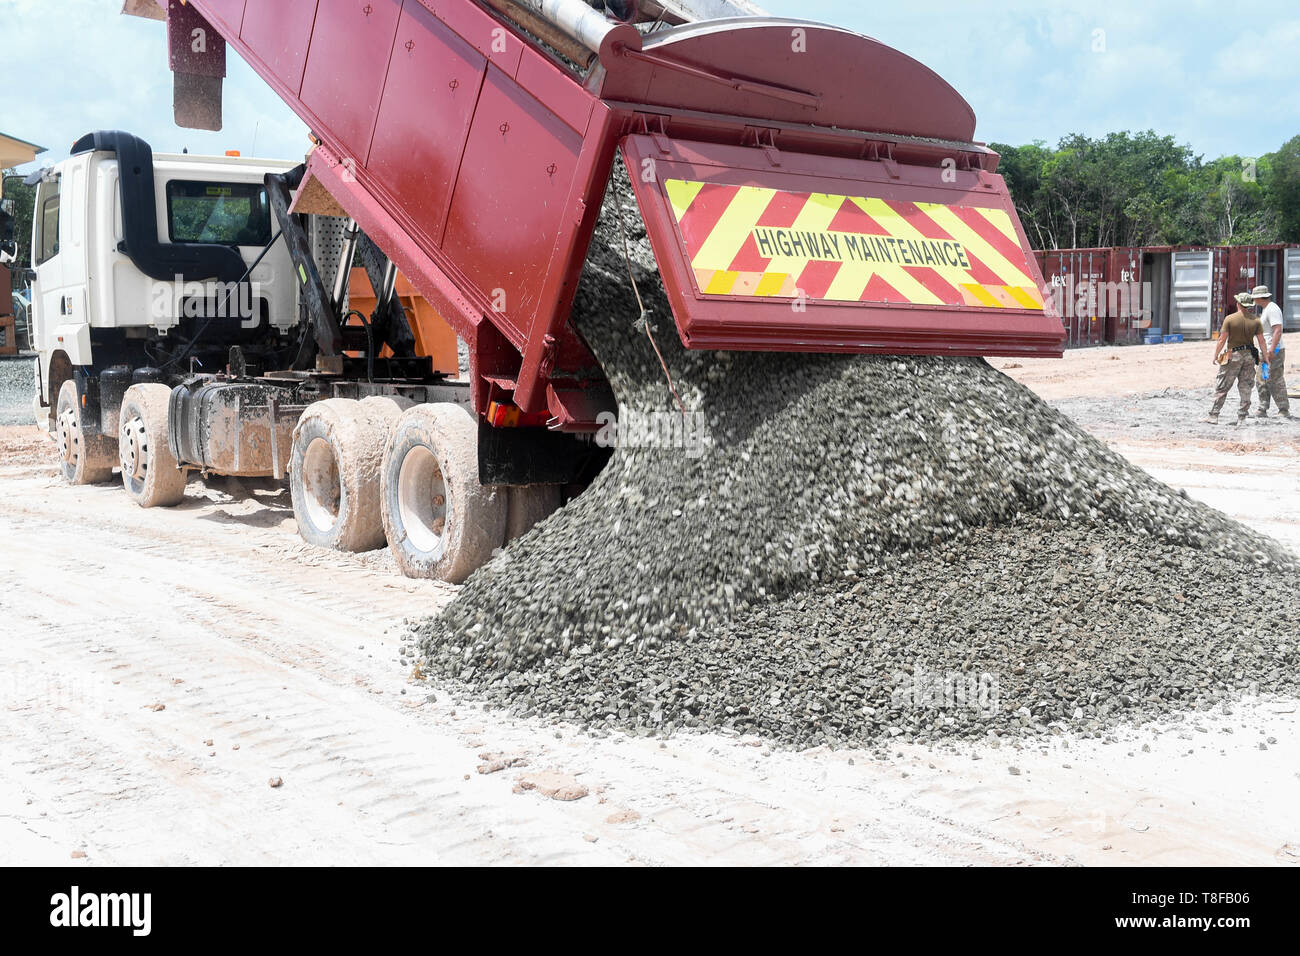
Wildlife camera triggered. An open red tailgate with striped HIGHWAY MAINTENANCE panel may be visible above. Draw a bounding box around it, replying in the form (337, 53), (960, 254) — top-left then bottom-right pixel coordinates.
(621, 135), (1065, 356)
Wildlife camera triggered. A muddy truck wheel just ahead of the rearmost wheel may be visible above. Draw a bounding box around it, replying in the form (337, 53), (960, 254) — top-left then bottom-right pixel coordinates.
(289, 398), (387, 551)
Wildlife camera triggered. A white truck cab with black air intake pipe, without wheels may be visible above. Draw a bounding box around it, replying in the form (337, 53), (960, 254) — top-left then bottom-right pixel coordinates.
(31, 133), (299, 432)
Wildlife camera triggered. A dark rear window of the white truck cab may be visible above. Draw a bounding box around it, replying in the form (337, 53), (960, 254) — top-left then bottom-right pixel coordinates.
(166, 179), (270, 246)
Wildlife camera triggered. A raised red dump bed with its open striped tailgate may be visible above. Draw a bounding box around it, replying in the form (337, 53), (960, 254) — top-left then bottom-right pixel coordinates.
(147, 0), (1063, 428)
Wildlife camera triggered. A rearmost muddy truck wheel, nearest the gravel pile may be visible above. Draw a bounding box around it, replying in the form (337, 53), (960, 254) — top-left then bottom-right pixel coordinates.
(384, 402), (506, 584)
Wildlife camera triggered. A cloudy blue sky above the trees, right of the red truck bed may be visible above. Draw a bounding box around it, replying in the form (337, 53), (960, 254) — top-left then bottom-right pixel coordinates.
(764, 0), (1300, 157)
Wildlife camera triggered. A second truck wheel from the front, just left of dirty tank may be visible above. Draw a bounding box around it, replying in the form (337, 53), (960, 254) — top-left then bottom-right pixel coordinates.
(117, 382), (187, 507)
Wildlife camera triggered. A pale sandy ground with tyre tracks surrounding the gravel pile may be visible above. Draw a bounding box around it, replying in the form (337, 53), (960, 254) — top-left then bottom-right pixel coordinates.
(0, 343), (1300, 865)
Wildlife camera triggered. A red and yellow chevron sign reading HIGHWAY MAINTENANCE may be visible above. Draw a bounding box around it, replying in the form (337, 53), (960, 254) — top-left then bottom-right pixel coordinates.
(664, 179), (1043, 312)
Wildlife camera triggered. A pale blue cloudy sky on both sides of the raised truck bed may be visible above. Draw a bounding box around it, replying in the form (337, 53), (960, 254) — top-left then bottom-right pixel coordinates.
(0, 0), (1300, 178)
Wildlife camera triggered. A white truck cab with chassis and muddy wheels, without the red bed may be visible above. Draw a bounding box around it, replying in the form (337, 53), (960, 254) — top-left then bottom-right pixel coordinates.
(31, 130), (496, 581)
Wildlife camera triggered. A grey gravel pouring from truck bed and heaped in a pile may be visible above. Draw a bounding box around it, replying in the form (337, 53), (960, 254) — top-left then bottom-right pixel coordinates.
(419, 170), (1300, 747)
